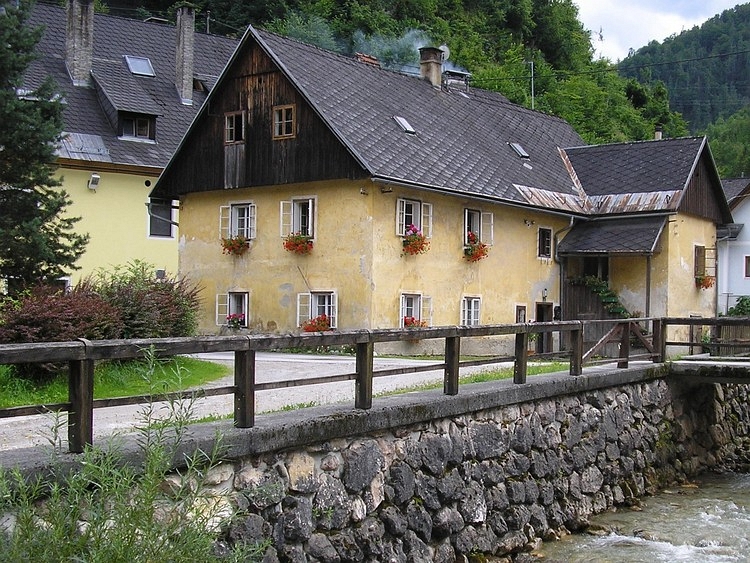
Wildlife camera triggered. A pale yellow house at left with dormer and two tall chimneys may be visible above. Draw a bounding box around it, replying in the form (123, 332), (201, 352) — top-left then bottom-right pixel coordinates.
(19, 0), (237, 281)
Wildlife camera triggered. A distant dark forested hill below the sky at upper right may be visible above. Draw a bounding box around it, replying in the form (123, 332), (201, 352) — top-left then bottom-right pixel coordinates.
(619, 4), (750, 132)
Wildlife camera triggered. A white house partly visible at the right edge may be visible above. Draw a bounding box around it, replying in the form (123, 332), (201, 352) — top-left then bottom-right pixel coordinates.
(717, 178), (750, 314)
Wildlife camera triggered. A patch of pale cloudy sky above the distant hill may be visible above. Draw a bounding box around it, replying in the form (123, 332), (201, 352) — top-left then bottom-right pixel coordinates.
(573, 0), (744, 62)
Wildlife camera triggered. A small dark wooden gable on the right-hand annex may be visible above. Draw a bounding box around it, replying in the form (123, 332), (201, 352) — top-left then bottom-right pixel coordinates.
(679, 149), (731, 225)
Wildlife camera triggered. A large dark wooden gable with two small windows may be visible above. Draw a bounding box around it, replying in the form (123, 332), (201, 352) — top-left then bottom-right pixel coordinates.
(159, 38), (367, 196)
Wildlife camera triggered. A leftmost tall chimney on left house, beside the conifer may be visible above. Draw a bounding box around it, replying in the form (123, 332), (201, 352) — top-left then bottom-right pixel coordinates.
(65, 0), (94, 86)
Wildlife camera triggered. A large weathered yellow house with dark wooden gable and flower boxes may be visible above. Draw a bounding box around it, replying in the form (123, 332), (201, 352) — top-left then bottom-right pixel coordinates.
(151, 27), (731, 350)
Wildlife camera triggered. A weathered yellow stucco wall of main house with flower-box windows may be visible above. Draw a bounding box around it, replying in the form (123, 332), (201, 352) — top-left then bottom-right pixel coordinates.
(179, 180), (568, 333)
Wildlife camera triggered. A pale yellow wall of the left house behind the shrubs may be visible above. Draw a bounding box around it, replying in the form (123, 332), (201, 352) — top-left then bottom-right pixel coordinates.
(60, 169), (178, 284)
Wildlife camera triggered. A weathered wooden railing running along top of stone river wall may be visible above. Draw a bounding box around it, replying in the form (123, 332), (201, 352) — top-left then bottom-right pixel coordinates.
(0, 319), (749, 453)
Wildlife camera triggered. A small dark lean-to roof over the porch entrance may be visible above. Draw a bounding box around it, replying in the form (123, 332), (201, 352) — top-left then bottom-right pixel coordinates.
(557, 217), (667, 256)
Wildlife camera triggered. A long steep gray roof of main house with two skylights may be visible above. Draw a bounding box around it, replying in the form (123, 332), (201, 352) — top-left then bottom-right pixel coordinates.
(155, 27), (584, 213)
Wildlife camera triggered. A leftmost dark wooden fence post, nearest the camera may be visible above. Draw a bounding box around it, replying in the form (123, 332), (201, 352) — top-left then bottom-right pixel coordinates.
(68, 360), (94, 454)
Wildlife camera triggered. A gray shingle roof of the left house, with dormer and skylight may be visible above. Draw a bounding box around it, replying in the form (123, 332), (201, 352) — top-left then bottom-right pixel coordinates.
(25, 3), (237, 168)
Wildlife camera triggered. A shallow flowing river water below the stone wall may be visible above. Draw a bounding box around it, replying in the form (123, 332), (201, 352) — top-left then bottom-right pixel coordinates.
(539, 474), (750, 563)
